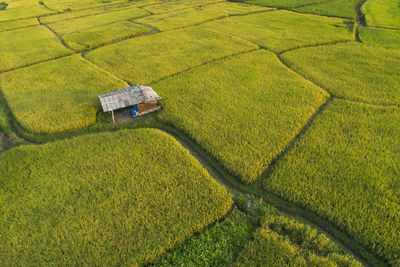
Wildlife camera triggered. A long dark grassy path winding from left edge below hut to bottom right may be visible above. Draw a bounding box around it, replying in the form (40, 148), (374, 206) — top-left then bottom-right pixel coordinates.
(0, 89), (385, 266)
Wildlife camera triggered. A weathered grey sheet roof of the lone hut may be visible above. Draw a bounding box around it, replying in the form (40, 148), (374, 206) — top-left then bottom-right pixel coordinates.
(99, 86), (161, 112)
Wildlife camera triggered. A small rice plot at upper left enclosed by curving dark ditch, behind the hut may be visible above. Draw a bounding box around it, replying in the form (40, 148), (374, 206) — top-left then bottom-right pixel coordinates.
(62, 21), (152, 50)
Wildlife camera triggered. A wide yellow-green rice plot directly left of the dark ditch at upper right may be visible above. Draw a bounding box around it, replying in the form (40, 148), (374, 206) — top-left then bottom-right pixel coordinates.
(200, 10), (353, 52)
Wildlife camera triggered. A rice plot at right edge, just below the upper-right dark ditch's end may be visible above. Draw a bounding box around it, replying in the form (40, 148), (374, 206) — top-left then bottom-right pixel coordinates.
(282, 43), (400, 104)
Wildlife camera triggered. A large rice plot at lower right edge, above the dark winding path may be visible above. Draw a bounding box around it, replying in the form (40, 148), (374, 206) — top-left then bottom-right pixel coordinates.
(264, 100), (400, 264)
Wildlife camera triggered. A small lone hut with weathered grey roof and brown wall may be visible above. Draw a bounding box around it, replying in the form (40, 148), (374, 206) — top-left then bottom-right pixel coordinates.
(99, 86), (161, 123)
